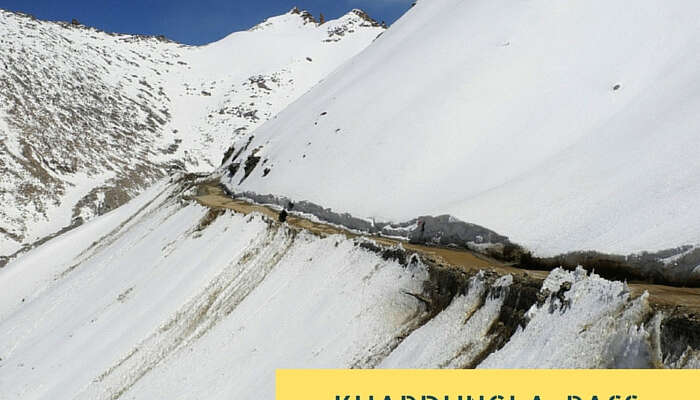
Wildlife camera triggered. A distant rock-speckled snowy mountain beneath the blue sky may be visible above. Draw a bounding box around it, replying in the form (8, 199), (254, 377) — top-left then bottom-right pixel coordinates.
(0, 10), (383, 256)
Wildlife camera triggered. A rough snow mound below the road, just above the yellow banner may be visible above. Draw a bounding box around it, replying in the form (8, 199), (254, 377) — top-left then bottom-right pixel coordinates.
(479, 268), (661, 368)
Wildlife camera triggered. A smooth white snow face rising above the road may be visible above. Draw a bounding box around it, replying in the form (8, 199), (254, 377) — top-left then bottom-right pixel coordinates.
(224, 0), (700, 255)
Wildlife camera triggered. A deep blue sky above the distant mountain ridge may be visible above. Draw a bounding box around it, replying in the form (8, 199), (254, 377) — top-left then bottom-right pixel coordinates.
(0, 0), (412, 44)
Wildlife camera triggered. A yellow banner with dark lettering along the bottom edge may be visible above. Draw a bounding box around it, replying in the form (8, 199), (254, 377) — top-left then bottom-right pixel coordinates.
(276, 370), (700, 400)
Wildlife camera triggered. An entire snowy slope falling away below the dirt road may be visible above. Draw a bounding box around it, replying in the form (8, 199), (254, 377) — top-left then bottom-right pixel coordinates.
(0, 176), (700, 399)
